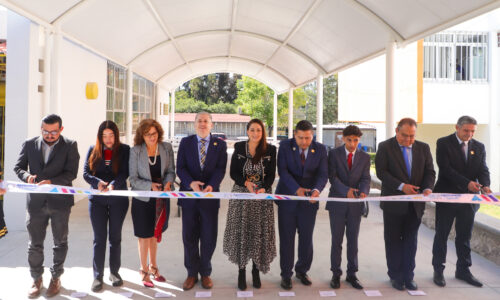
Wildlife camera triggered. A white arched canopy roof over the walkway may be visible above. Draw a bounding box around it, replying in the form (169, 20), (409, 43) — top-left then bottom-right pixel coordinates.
(0, 0), (500, 93)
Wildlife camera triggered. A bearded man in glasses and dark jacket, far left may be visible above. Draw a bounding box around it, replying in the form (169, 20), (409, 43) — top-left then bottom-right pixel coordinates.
(14, 115), (80, 298)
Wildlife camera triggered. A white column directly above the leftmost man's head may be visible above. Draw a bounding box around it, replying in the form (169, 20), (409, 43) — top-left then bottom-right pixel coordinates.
(50, 26), (64, 113)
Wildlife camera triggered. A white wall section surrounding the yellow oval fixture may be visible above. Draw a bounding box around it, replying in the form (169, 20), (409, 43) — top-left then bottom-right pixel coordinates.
(60, 39), (107, 191)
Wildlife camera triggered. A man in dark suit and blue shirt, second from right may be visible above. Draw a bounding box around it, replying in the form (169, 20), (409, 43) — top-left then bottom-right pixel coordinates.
(375, 118), (436, 290)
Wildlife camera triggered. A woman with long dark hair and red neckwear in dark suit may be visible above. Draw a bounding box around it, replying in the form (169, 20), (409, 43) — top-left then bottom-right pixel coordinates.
(83, 121), (130, 292)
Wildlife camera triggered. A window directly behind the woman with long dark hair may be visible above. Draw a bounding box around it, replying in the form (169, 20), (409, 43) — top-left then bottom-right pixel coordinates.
(106, 61), (127, 136)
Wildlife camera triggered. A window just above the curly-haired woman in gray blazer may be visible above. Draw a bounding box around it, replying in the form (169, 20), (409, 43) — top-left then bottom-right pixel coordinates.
(132, 74), (154, 131)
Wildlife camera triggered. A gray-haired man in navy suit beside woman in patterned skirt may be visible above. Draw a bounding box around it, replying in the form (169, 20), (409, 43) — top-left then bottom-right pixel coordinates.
(177, 112), (227, 290)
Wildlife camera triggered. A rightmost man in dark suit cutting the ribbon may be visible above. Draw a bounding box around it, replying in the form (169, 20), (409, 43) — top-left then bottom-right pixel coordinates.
(432, 116), (491, 287)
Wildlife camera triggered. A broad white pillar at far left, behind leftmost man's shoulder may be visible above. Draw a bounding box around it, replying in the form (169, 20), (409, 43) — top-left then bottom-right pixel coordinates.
(3, 10), (39, 229)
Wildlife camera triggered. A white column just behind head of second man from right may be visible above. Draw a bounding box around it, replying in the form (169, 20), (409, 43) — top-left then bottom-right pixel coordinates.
(385, 41), (396, 139)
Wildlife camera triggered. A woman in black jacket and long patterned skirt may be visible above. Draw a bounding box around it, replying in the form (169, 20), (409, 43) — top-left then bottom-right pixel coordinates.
(223, 119), (276, 290)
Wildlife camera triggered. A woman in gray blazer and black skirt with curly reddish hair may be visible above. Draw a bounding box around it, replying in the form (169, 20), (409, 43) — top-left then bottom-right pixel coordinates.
(129, 119), (175, 287)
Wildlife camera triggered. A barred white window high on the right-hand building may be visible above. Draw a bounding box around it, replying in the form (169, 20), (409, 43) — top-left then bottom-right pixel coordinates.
(423, 32), (488, 82)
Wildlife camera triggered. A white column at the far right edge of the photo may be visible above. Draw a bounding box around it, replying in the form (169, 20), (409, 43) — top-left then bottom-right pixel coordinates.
(486, 31), (500, 192)
